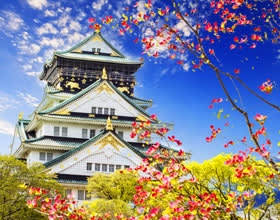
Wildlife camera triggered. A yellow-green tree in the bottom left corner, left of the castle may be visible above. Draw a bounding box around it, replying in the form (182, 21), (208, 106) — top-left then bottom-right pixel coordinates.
(0, 155), (59, 220)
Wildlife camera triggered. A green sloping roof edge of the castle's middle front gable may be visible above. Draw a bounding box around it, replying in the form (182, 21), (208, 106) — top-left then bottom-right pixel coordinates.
(38, 79), (154, 122)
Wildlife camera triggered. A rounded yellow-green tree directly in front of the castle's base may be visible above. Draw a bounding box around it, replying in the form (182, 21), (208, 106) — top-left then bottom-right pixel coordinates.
(87, 170), (137, 219)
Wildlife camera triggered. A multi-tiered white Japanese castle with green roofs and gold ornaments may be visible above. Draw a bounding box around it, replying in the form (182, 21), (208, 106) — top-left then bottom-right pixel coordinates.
(13, 32), (175, 200)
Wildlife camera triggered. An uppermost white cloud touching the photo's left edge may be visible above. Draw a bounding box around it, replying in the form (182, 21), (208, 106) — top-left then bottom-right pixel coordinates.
(0, 11), (24, 36)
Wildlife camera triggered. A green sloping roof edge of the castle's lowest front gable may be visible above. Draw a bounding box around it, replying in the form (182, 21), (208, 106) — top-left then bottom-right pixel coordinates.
(44, 130), (145, 168)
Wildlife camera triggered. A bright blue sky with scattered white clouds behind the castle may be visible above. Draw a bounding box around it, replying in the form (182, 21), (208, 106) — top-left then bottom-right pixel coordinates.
(0, 0), (280, 161)
